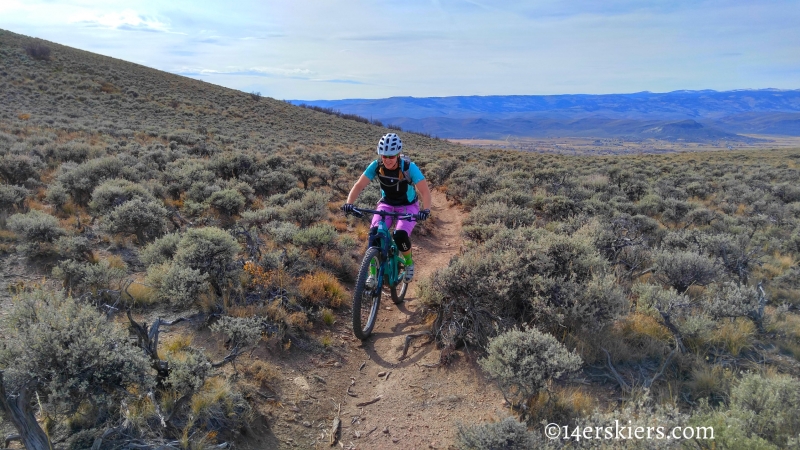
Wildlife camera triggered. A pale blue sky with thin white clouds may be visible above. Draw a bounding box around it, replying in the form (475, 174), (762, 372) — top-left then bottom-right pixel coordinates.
(0, 0), (800, 100)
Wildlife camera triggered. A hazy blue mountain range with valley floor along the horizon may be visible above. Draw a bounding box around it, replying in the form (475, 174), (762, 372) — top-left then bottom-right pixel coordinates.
(290, 89), (800, 142)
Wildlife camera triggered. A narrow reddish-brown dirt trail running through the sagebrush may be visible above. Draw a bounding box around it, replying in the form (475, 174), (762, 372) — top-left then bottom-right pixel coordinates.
(260, 192), (507, 449)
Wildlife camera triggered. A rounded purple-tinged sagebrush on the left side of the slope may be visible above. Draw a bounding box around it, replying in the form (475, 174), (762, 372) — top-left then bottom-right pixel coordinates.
(103, 198), (168, 245)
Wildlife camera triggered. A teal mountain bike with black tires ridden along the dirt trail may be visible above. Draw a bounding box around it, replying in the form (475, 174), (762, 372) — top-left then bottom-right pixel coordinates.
(351, 208), (419, 341)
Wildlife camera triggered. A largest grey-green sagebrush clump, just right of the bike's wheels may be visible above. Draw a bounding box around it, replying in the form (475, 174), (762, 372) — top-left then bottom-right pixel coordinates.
(424, 226), (626, 346)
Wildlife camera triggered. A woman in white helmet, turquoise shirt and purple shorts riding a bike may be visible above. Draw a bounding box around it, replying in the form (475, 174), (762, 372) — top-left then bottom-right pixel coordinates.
(342, 133), (431, 286)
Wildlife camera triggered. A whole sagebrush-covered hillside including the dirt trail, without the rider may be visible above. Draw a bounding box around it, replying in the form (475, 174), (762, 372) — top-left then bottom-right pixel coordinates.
(0, 27), (800, 450)
